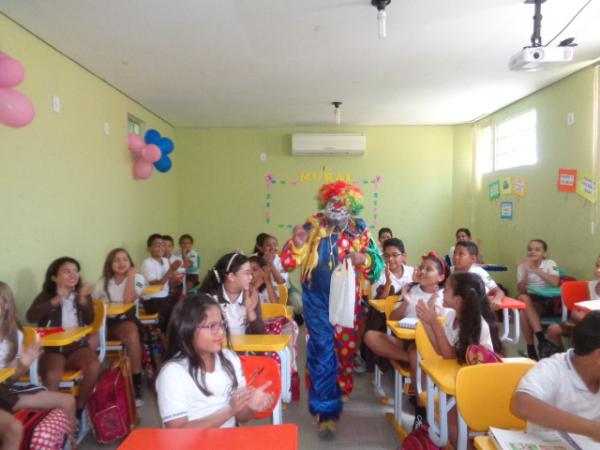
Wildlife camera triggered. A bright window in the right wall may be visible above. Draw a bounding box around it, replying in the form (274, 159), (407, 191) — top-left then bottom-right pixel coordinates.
(494, 109), (537, 170)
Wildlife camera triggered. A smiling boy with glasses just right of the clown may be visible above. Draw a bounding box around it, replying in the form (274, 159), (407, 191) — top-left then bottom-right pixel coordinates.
(371, 238), (415, 298)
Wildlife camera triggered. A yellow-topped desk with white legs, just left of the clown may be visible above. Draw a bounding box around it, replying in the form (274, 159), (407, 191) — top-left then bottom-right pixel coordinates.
(226, 334), (292, 425)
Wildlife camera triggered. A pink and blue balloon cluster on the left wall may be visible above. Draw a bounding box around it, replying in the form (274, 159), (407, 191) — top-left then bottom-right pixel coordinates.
(127, 130), (175, 180)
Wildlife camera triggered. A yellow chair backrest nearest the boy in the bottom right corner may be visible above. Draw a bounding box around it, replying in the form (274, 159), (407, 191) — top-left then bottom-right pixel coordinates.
(456, 360), (535, 432)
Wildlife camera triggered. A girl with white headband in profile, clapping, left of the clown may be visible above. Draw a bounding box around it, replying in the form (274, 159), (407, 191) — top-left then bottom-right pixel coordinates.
(200, 252), (265, 335)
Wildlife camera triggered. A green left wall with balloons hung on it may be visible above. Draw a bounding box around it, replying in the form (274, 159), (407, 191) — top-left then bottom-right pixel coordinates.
(0, 14), (178, 317)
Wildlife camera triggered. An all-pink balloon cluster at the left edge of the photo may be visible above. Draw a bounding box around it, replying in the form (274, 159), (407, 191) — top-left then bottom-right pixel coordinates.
(0, 52), (34, 128)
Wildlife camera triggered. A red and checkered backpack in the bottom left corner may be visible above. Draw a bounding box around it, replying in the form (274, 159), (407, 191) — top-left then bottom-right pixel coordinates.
(15, 408), (73, 450)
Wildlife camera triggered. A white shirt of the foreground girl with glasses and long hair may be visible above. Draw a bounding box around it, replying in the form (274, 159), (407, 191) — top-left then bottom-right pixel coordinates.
(156, 350), (246, 428)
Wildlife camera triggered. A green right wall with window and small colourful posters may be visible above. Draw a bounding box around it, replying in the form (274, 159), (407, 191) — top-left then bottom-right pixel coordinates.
(472, 66), (600, 293)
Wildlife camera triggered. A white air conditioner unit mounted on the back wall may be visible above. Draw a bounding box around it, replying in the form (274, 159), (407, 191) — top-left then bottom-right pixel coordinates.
(292, 133), (367, 156)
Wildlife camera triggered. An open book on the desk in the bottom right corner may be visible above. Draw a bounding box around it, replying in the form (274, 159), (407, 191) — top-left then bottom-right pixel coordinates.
(489, 428), (600, 450)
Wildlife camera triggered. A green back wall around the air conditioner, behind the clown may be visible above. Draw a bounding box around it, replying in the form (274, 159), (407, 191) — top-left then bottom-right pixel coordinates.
(176, 126), (464, 272)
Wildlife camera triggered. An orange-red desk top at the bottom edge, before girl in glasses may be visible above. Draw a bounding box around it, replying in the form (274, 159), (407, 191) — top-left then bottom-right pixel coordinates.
(119, 424), (298, 450)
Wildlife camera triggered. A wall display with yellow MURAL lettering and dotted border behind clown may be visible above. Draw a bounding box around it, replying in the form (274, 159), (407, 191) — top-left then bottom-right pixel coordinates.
(264, 171), (383, 229)
